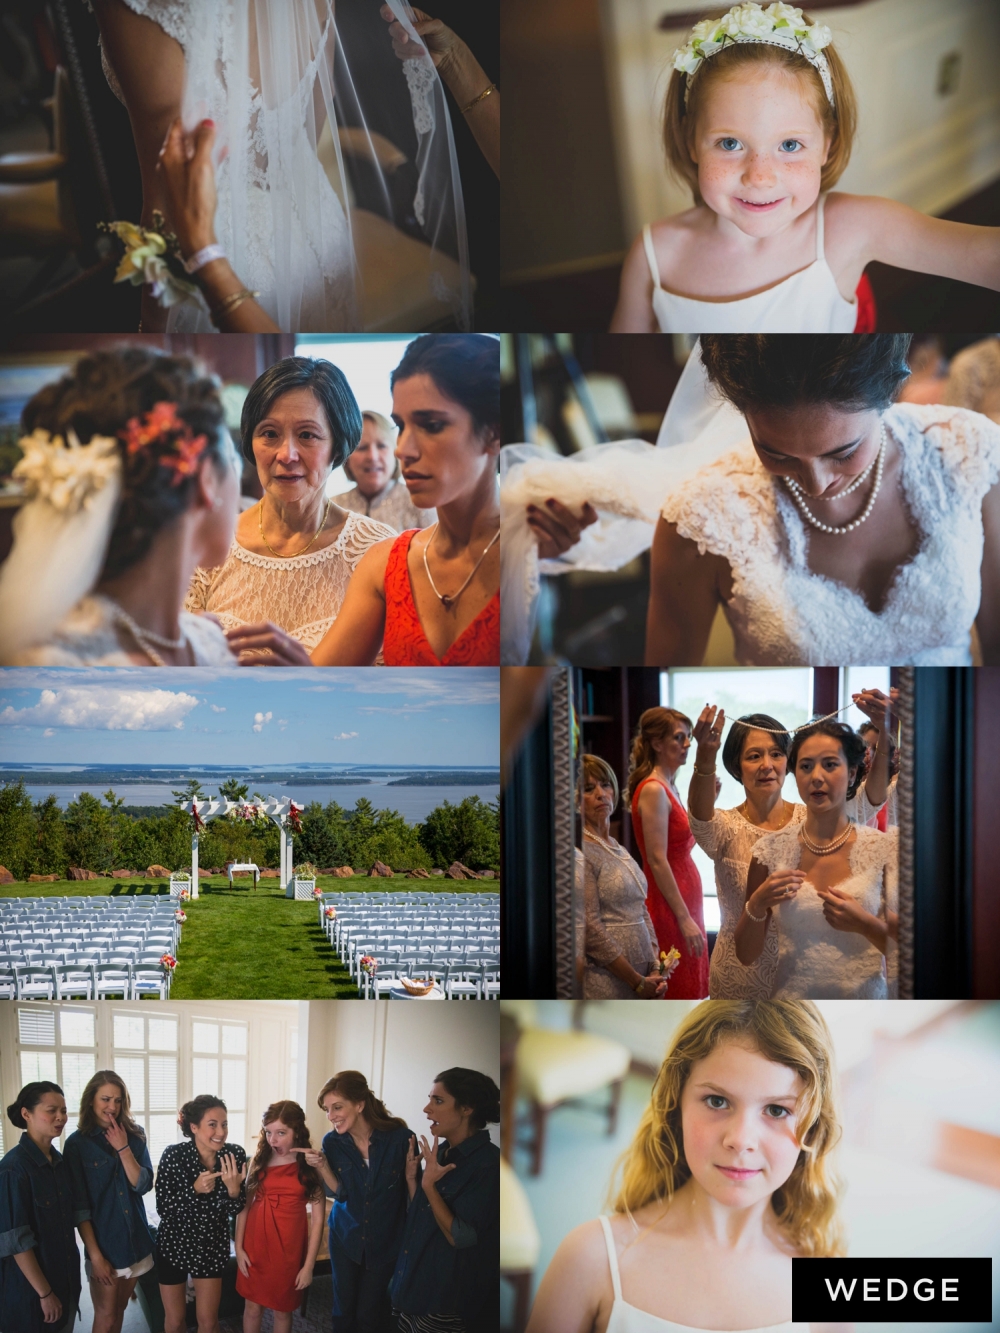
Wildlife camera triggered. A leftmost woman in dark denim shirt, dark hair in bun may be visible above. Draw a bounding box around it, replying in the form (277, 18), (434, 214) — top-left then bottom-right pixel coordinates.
(0, 1080), (80, 1333)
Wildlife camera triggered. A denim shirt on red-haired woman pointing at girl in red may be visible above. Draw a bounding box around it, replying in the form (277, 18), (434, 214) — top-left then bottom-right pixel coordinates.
(323, 1128), (411, 1268)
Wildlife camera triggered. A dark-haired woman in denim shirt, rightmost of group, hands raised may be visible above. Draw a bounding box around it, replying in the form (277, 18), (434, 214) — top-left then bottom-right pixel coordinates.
(389, 1068), (500, 1333)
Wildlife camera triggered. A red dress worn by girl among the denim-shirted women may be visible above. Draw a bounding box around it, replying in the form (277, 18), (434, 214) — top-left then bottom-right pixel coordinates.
(236, 1162), (309, 1312)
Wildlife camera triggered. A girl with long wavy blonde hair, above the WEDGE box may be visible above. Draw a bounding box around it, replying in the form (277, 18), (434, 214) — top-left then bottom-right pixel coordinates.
(528, 1000), (852, 1333)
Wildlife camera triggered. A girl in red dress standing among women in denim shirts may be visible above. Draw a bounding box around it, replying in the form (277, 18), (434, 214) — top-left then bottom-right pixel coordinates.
(236, 1101), (327, 1333)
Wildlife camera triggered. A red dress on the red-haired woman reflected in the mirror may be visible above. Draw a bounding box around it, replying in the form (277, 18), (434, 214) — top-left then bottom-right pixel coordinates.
(632, 776), (708, 1000)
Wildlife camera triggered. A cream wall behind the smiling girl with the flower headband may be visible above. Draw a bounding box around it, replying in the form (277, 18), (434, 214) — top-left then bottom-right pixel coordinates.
(601, 0), (1000, 239)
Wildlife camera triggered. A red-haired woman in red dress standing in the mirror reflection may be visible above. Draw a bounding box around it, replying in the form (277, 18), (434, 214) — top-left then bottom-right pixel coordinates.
(628, 708), (708, 1000)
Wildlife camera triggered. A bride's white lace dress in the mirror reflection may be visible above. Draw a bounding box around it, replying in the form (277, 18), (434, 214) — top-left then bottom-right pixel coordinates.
(753, 825), (899, 1000)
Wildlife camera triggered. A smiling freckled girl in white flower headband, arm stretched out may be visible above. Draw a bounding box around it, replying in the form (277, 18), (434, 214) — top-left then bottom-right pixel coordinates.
(611, 3), (1000, 333)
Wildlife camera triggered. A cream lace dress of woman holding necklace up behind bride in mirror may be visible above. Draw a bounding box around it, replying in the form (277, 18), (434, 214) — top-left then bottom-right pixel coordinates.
(688, 805), (805, 1000)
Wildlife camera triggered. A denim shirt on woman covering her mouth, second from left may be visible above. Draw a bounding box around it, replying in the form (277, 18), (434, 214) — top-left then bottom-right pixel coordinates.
(65, 1129), (153, 1268)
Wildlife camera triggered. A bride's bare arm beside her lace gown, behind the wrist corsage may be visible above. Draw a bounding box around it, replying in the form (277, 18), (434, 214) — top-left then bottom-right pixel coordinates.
(93, 0), (184, 333)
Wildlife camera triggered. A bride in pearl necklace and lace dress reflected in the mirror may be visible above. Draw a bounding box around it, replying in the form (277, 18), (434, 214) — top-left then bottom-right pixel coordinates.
(735, 718), (897, 1000)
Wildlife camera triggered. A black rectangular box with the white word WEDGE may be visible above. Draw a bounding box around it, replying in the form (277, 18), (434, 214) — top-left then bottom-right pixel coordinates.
(792, 1258), (993, 1324)
